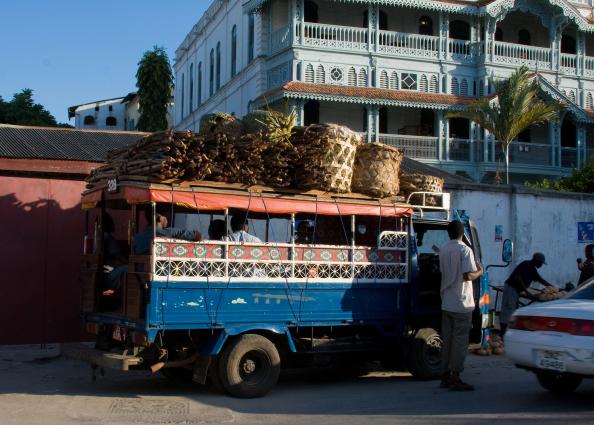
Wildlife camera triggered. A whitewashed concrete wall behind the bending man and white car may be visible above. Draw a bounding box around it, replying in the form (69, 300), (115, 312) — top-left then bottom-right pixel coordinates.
(446, 185), (594, 286)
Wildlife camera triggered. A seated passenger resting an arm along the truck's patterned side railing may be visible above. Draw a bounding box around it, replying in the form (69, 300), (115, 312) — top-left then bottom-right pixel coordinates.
(133, 205), (202, 255)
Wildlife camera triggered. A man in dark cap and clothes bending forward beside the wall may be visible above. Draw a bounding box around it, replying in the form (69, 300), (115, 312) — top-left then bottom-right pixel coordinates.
(499, 252), (553, 337)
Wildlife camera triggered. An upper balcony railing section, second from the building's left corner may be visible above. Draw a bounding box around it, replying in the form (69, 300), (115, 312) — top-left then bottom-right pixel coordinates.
(378, 31), (439, 58)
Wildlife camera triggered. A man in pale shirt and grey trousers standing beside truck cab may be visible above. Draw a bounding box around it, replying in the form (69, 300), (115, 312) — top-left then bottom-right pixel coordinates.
(439, 220), (483, 391)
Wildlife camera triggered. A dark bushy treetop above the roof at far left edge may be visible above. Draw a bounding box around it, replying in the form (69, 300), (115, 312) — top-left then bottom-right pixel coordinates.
(0, 89), (72, 127)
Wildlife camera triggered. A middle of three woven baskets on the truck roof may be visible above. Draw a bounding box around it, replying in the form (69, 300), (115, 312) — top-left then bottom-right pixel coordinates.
(351, 143), (402, 198)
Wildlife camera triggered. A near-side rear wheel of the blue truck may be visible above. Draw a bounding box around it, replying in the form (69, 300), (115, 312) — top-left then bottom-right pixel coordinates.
(219, 334), (280, 398)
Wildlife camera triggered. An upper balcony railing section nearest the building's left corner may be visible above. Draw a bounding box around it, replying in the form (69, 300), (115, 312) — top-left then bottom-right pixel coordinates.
(295, 22), (368, 51)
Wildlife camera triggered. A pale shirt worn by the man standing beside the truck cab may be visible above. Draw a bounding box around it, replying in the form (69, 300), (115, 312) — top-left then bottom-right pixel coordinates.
(439, 239), (477, 313)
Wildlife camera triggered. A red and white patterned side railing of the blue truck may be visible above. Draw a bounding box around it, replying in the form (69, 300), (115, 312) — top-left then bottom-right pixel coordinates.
(153, 231), (408, 283)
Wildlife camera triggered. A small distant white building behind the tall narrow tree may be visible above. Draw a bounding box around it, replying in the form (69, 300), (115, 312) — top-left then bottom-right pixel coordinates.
(68, 92), (173, 131)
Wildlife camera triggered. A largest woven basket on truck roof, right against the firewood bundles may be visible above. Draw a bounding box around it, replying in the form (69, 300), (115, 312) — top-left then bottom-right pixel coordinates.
(292, 124), (361, 193)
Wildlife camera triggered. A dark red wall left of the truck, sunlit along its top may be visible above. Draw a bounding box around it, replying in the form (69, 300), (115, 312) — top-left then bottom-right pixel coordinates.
(0, 176), (88, 344)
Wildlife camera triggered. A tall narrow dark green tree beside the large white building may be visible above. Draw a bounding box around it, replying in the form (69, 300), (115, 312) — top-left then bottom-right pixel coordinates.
(136, 46), (173, 131)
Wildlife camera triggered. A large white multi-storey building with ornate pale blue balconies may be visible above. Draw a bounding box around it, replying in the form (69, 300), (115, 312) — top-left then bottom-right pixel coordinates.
(174, 0), (594, 182)
